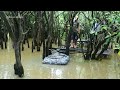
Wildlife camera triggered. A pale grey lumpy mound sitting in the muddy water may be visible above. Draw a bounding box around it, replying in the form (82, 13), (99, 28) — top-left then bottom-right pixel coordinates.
(42, 52), (70, 65)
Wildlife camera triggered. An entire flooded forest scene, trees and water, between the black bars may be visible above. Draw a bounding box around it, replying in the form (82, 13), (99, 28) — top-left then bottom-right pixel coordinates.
(0, 11), (120, 79)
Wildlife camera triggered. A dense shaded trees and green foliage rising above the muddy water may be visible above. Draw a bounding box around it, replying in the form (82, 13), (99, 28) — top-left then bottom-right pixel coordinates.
(0, 11), (120, 77)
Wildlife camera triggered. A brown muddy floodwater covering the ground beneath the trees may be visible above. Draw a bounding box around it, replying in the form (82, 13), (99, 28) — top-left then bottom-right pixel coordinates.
(0, 38), (120, 79)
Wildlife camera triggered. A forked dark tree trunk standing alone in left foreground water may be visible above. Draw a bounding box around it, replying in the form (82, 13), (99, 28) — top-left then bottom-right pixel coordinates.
(0, 11), (24, 77)
